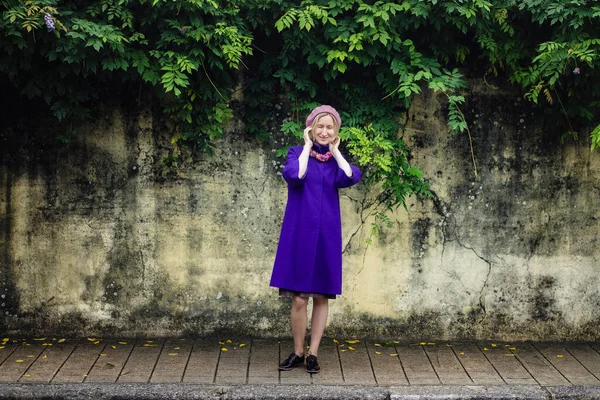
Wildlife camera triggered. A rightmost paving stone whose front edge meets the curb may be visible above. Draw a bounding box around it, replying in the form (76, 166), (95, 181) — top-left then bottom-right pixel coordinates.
(534, 343), (600, 385)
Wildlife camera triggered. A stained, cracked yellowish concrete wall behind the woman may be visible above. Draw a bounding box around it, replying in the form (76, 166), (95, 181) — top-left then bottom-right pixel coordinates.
(0, 87), (600, 340)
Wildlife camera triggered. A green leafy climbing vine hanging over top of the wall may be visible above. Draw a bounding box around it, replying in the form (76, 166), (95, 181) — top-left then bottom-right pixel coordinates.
(0, 0), (600, 225)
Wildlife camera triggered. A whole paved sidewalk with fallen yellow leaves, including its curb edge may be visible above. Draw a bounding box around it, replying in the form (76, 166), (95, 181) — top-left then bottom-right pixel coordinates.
(0, 337), (600, 399)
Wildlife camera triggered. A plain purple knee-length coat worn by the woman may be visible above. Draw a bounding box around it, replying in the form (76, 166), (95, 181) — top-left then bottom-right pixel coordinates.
(271, 144), (360, 294)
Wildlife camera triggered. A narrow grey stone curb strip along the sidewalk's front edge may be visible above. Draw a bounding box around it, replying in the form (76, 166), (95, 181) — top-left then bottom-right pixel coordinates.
(0, 383), (600, 400)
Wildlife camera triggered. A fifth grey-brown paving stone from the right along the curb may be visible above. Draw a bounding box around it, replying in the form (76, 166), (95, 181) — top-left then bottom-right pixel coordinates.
(423, 343), (473, 385)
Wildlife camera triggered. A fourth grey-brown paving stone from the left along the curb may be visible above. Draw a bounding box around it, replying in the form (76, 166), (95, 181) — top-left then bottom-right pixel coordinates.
(85, 339), (136, 383)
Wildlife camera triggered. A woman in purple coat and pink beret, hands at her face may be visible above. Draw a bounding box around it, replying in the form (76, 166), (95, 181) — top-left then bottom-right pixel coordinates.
(271, 105), (360, 373)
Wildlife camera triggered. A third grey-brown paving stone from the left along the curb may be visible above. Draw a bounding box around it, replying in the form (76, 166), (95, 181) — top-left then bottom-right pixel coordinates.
(52, 338), (106, 383)
